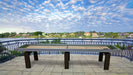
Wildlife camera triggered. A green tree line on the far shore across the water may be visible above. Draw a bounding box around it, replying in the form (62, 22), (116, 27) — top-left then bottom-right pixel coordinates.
(0, 31), (133, 38)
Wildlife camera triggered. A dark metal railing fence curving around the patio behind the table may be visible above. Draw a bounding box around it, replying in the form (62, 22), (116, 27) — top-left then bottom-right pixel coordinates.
(0, 39), (133, 63)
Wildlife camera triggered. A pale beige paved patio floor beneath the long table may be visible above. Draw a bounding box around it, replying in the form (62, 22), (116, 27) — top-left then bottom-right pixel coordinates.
(0, 54), (133, 75)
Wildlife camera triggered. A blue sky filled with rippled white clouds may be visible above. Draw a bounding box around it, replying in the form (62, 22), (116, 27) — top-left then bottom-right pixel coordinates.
(0, 0), (133, 33)
